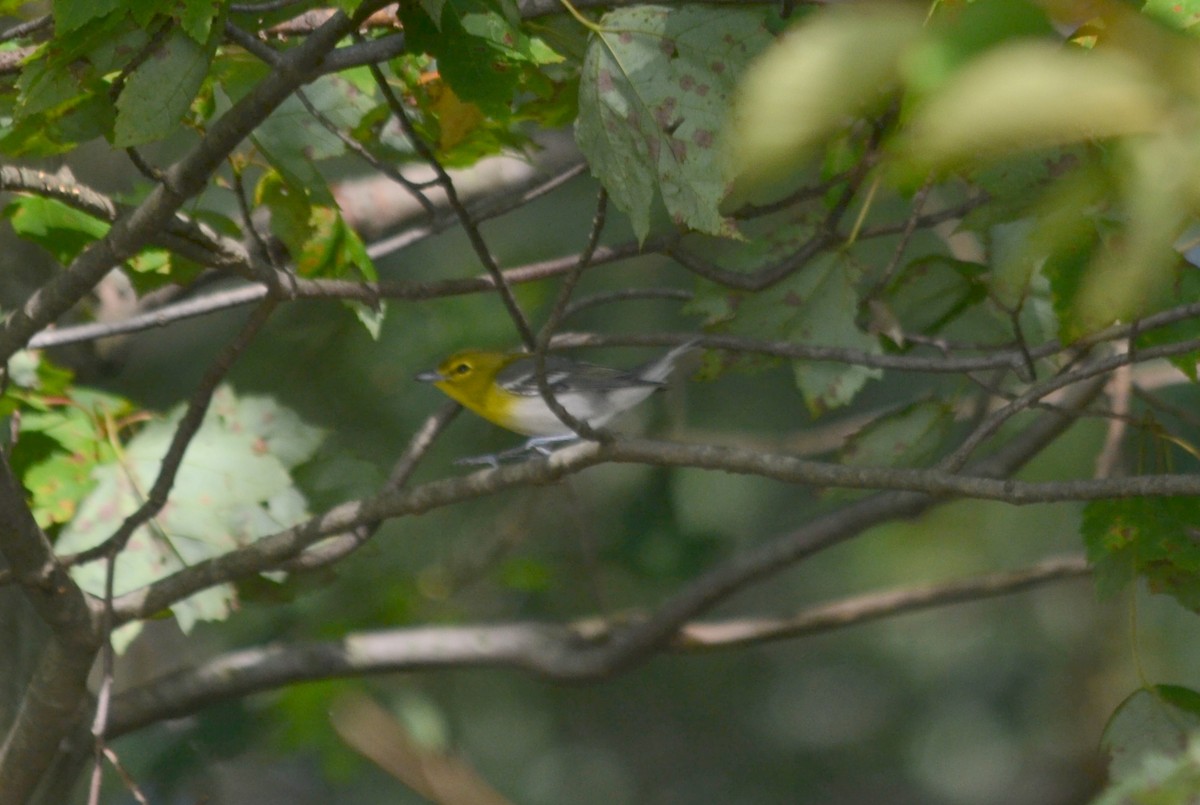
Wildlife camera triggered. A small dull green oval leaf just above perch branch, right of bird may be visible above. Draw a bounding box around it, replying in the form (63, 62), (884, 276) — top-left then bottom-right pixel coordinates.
(841, 401), (954, 467)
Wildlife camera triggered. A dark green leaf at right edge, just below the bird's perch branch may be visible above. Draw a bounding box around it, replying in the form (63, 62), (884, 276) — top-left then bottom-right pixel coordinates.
(1080, 498), (1200, 611)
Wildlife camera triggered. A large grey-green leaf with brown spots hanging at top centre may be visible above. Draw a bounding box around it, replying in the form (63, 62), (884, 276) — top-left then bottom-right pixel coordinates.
(575, 6), (772, 240)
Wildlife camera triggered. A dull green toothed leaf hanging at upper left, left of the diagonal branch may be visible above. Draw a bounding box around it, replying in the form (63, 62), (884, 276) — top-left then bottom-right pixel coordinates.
(113, 30), (217, 148)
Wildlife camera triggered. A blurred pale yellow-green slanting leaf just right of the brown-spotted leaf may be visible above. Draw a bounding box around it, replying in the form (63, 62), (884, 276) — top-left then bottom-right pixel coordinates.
(724, 4), (922, 192)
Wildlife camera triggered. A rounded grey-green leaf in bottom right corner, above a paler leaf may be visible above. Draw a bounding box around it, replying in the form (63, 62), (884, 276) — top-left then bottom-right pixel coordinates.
(1100, 685), (1200, 780)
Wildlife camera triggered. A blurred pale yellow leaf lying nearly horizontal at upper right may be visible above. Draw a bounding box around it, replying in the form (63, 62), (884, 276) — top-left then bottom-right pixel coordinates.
(899, 42), (1168, 176)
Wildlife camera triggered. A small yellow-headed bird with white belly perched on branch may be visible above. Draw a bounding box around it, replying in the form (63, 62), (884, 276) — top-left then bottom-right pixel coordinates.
(416, 341), (695, 463)
